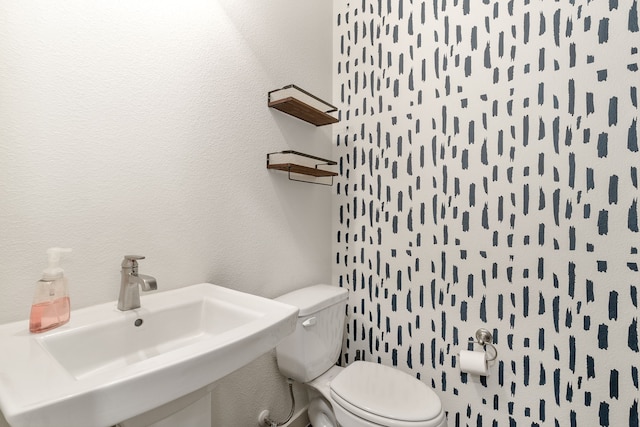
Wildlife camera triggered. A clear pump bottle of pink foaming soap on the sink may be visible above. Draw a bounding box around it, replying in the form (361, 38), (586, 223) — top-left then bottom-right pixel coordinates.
(29, 248), (71, 333)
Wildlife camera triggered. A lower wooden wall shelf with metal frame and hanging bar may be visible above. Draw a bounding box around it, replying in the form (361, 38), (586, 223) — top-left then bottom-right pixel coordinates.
(267, 150), (338, 185)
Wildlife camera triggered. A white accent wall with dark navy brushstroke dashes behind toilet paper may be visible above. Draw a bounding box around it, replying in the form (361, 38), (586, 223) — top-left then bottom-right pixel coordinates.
(334, 0), (640, 427)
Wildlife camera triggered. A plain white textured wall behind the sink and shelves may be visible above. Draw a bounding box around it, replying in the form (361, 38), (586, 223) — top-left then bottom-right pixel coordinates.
(0, 0), (332, 425)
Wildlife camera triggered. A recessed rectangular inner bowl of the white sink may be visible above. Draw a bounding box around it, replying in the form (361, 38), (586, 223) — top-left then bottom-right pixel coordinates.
(36, 295), (262, 379)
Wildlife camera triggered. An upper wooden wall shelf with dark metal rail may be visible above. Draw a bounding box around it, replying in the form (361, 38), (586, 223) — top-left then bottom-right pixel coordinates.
(268, 85), (340, 126)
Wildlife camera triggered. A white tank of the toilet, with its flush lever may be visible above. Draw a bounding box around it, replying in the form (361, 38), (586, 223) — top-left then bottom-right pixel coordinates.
(276, 285), (348, 383)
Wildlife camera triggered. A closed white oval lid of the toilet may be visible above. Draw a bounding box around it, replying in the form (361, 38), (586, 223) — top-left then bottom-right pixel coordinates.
(330, 361), (442, 422)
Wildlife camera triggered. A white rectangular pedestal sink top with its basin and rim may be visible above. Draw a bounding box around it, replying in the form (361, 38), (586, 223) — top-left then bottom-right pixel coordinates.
(0, 283), (298, 427)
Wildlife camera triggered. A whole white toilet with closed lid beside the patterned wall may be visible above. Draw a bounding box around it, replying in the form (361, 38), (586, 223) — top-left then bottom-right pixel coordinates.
(276, 285), (447, 427)
